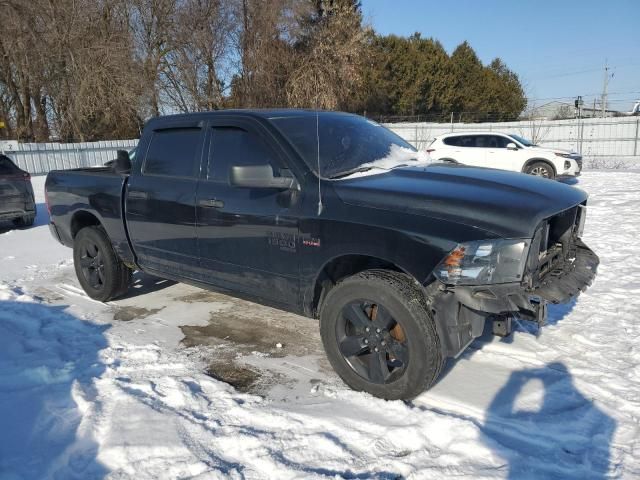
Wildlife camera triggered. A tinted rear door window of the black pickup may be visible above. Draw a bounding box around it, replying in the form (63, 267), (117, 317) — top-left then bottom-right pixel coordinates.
(144, 128), (202, 177)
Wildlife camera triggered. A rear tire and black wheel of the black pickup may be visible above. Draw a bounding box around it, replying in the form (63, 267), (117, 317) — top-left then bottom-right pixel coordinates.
(73, 226), (132, 302)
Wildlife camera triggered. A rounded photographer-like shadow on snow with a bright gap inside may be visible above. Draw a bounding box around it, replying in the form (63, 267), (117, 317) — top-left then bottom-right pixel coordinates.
(480, 362), (616, 479)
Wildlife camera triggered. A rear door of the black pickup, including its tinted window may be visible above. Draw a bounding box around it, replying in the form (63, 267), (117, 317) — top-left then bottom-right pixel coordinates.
(125, 121), (205, 278)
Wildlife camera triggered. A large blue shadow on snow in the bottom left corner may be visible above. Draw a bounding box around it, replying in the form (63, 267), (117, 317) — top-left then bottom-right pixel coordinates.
(0, 301), (108, 479)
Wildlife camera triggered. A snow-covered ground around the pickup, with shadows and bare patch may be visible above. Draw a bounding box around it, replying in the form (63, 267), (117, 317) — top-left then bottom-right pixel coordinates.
(0, 171), (640, 480)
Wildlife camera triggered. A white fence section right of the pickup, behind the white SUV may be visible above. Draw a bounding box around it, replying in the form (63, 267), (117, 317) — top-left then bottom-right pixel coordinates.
(386, 117), (640, 165)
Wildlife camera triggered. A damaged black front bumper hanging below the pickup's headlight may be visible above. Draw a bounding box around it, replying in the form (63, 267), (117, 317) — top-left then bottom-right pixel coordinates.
(432, 240), (600, 357)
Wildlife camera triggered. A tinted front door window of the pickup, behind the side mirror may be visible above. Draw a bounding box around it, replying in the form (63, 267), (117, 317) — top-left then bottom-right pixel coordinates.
(207, 127), (278, 182)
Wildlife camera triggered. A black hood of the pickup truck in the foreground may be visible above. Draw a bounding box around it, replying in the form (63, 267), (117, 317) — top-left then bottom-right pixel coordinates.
(333, 164), (587, 238)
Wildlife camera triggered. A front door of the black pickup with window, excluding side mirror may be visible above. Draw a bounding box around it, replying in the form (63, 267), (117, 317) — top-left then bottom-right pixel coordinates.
(196, 117), (299, 304)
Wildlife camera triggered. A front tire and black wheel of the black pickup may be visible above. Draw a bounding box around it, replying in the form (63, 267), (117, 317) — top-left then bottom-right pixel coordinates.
(320, 270), (445, 400)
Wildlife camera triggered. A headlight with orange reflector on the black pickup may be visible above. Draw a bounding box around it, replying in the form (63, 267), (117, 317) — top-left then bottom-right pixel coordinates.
(434, 239), (529, 285)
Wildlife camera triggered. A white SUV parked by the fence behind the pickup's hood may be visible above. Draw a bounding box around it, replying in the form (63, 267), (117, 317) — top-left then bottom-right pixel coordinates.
(427, 132), (582, 178)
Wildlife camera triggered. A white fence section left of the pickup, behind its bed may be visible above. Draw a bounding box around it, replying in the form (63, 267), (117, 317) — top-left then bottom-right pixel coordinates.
(0, 140), (138, 175)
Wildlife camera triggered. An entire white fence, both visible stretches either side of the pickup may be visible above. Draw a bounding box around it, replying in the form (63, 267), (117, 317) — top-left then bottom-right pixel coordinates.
(0, 117), (640, 174)
